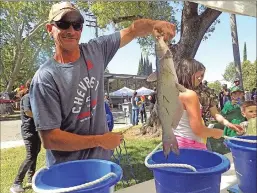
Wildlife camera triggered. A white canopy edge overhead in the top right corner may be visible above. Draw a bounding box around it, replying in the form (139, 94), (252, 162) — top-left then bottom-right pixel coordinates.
(191, 1), (256, 17)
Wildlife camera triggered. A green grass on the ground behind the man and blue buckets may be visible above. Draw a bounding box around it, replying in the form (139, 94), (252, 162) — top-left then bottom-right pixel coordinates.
(0, 136), (159, 193)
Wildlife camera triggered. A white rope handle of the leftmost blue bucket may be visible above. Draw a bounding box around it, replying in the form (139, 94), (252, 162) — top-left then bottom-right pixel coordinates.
(32, 167), (117, 193)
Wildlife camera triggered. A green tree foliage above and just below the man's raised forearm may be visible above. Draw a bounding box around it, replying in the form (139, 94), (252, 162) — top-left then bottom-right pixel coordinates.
(86, 1), (178, 53)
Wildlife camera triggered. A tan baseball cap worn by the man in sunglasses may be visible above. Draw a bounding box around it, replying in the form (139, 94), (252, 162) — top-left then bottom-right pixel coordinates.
(48, 2), (84, 23)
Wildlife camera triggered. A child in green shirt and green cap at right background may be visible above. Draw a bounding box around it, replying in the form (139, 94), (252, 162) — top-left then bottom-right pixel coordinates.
(221, 86), (245, 137)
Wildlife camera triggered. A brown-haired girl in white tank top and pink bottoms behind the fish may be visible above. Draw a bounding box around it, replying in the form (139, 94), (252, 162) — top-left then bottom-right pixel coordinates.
(173, 59), (223, 150)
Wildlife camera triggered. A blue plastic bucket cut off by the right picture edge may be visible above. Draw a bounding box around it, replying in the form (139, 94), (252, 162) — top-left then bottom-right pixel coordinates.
(225, 136), (257, 193)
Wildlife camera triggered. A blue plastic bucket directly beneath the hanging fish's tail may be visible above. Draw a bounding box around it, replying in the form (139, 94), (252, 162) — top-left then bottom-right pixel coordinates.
(147, 149), (230, 193)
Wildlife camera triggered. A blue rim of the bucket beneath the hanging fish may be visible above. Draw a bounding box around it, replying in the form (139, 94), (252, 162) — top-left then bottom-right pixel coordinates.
(148, 148), (230, 175)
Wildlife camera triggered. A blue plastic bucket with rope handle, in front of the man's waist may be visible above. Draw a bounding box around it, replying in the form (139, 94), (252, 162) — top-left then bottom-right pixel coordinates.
(32, 159), (122, 193)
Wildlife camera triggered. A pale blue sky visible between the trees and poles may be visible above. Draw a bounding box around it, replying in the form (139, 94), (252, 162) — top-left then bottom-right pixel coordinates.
(81, 7), (256, 82)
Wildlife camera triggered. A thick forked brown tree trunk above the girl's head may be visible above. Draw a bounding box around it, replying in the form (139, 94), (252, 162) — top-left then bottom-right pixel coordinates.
(170, 2), (221, 66)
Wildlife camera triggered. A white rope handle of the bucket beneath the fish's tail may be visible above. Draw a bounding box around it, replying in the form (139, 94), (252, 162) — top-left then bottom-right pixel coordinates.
(145, 142), (196, 172)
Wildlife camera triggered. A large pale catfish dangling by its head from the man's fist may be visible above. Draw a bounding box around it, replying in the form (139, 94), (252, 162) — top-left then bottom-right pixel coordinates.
(148, 37), (186, 159)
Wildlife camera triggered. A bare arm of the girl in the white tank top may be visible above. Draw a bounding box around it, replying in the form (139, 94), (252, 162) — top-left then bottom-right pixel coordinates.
(180, 90), (223, 139)
